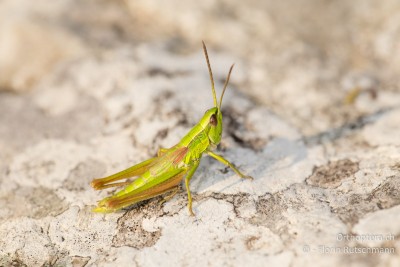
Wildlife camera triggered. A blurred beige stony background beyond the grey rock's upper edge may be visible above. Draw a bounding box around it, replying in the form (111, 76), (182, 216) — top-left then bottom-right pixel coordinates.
(0, 0), (400, 135)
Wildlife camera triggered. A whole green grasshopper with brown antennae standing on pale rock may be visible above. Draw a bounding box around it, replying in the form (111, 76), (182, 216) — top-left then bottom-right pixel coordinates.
(91, 42), (253, 216)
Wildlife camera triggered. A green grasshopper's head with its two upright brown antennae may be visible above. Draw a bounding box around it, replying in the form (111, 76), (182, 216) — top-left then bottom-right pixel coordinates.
(202, 42), (234, 148)
